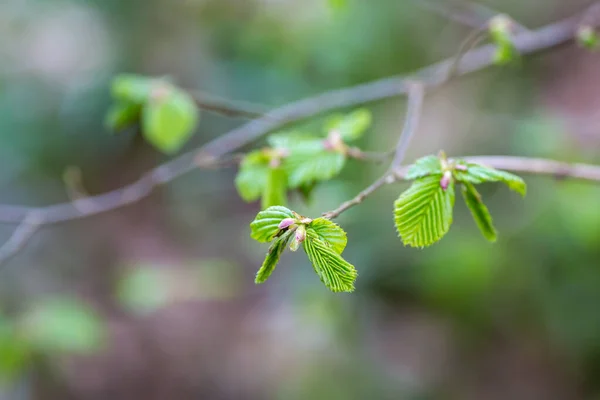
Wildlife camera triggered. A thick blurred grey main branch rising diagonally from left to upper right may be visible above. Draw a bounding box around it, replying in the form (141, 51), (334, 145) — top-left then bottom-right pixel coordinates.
(0, 2), (596, 231)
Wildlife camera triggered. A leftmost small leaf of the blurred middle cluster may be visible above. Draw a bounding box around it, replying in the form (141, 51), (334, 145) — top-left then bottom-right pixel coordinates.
(235, 150), (270, 202)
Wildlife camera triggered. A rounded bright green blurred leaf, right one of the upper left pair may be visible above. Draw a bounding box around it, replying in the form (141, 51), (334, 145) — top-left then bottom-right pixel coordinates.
(142, 86), (199, 154)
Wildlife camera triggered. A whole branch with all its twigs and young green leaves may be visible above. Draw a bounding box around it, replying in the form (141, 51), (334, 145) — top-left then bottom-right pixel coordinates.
(0, 2), (600, 292)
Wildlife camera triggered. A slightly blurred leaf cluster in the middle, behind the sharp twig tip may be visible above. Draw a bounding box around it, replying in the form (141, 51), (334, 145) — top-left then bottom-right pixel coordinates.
(235, 109), (371, 209)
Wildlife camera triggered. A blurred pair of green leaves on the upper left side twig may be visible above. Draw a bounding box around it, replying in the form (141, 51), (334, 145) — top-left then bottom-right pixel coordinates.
(105, 74), (199, 154)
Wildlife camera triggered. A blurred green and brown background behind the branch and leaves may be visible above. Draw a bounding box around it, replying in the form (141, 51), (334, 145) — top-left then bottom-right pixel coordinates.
(0, 0), (600, 400)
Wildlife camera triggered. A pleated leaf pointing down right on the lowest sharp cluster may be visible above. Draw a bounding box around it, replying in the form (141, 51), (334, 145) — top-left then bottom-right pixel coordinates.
(303, 227), (358, 292)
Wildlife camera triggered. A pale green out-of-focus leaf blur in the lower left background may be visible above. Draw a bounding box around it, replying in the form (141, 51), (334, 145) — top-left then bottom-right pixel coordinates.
(24, 298), (106, 354)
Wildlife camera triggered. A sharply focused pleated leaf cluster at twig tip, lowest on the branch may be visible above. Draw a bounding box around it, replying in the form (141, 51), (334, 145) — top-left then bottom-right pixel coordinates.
(250, 206), (357, 292)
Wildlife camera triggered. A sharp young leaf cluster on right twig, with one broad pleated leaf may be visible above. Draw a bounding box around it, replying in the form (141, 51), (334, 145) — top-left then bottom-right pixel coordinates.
(394, 154), (526, 247)
